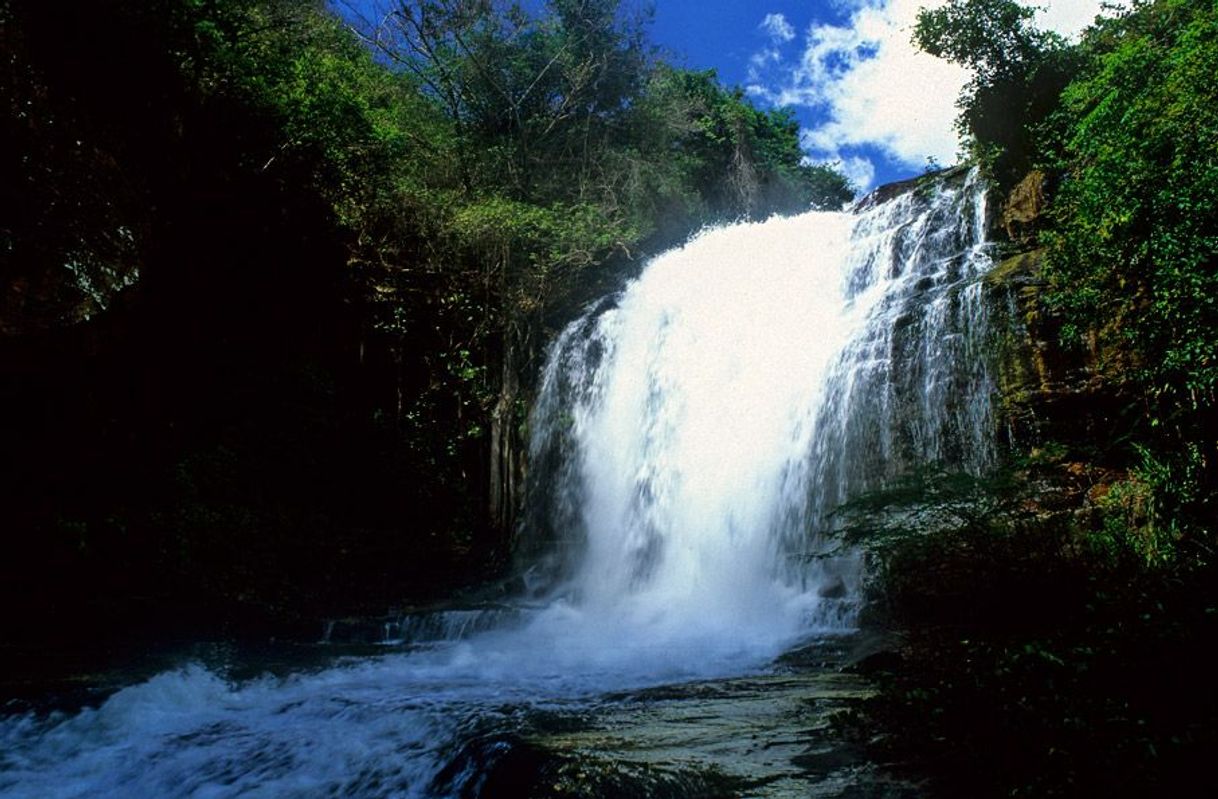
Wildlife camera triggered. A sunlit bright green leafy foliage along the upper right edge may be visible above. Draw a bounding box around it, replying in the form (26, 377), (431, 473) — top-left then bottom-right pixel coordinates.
(1046, 0), (1218, 555)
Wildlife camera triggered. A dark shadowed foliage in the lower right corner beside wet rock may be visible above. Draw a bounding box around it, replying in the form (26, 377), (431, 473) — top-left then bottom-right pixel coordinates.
(838, 465), (1218, 797)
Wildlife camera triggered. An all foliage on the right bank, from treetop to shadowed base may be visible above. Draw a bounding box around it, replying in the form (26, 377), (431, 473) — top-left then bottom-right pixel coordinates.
(844, 0), (1218, 797)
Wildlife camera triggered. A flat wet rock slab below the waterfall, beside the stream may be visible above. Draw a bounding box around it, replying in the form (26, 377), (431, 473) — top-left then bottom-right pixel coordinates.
(460, 636), (921, 799)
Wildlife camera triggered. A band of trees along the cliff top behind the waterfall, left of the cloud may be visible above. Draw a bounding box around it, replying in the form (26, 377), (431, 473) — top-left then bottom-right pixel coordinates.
(365, 0), (850, 227)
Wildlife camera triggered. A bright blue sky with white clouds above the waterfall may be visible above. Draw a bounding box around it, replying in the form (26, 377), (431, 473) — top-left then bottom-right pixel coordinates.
(336, 0), (1120, 190)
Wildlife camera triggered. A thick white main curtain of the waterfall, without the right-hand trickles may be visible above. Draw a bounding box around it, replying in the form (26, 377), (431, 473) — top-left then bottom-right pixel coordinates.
(533, 213), (866, 647)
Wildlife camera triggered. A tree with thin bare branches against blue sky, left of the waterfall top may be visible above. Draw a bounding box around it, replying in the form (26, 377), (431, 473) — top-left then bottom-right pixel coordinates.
(365, 0), (646, 200)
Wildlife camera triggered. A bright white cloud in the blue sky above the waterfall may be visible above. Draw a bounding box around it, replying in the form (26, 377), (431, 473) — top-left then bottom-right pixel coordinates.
(747, 0), (1130, 175)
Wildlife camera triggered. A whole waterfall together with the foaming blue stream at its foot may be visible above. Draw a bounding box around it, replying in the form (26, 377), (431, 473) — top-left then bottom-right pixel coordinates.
(0, 168), (993, 798)
